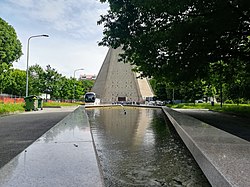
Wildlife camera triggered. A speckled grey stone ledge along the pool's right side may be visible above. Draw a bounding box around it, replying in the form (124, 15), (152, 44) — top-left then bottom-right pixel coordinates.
(162, 107), (250, 187)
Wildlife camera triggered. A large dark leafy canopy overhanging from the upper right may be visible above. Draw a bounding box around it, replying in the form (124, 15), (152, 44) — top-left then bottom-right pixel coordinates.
(98, 0), (250, 83)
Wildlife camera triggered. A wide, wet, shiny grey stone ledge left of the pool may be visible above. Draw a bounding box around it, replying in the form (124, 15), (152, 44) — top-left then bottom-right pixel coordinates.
(0, 107), (103, 187)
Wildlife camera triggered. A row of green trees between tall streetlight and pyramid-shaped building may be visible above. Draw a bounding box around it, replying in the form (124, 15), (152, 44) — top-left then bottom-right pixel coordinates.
(29, 64), (94, 100)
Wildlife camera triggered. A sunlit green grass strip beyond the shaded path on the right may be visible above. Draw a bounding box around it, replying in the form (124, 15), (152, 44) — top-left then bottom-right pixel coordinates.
(168, 103), (250, 116)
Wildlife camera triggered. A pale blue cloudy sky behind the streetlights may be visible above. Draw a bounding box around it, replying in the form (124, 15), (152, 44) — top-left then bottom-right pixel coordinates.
(0, 0), (108, 77)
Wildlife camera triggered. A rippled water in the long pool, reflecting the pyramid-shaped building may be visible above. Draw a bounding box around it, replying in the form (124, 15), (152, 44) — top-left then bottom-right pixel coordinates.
(87, 107), (210, 187)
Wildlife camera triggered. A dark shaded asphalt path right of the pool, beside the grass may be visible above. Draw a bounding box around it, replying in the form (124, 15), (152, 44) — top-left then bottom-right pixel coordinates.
(177, 109), (250, 141)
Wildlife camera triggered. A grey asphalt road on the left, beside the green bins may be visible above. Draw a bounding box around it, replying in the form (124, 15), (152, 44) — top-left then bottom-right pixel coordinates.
(0, 107), (76, 168)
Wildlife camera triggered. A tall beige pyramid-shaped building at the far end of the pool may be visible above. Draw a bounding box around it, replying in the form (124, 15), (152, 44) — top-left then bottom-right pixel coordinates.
(92, 47), (154, 104)
